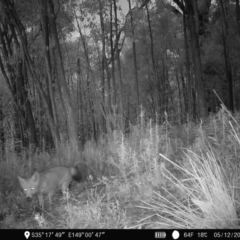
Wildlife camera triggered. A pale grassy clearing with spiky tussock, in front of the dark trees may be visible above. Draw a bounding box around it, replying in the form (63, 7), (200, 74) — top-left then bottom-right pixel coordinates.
(0, 107), (240, 229)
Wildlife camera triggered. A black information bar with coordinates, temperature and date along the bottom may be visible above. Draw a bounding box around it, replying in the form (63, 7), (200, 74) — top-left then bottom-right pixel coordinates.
(0, 229), (240, 240)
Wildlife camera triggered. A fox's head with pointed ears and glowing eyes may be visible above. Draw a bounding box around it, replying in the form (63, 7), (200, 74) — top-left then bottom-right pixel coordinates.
(18, 172), (39, 198)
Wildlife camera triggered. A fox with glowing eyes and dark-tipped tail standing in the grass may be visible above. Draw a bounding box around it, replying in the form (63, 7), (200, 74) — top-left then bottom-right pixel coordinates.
(18, 166), (82, 209)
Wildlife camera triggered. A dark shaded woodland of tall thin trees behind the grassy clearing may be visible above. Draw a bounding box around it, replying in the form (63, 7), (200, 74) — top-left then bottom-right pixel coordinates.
(0, 0), (240, 152)
